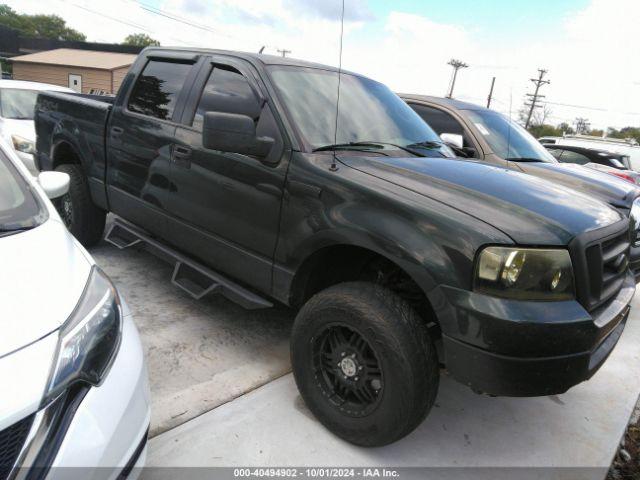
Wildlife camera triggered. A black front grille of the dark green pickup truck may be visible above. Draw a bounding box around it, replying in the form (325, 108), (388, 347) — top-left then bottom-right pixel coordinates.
(572, 221), (631, 311)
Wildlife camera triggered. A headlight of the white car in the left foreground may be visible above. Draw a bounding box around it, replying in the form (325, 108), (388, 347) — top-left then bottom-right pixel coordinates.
(43, 267), (122, 404)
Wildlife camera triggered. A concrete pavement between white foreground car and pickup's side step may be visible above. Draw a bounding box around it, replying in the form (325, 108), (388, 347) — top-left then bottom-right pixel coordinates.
(91, 238), (294, 436)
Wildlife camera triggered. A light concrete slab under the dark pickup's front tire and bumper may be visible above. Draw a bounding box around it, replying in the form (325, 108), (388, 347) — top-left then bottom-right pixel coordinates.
(144, 297), (640, 478)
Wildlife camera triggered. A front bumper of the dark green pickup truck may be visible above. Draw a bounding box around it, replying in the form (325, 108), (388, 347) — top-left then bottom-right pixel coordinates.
(441, 273), (635, 396)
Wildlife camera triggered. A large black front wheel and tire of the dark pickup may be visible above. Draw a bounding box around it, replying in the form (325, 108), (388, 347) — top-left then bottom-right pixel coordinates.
(291, 282), (439, 447)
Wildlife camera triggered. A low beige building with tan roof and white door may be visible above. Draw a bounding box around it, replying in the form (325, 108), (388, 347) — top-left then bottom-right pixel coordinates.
(11, 48), (136, 94)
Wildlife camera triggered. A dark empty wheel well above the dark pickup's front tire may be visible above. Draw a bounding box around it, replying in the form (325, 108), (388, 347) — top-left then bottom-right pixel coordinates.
(291, 245), (439, 330)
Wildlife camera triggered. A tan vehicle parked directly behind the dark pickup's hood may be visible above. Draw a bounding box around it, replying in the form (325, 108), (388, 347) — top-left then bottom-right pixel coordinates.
(400, 94), (640, 281)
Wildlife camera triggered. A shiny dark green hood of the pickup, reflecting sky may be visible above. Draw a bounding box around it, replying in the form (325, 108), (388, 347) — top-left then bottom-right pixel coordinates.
(339, 155), (623, 245)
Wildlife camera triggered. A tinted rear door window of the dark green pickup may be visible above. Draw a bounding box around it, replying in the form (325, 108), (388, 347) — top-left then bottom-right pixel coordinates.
(127, 60), (192, 120)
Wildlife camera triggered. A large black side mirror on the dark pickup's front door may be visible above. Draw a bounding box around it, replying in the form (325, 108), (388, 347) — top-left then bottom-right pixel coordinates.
(202, 112), (275, 158)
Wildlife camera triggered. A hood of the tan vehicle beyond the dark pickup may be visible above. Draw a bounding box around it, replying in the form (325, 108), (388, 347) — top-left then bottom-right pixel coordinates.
(517, 162), (640, 208)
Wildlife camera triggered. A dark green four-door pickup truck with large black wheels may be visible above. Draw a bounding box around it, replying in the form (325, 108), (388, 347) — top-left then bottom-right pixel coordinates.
(36, 48), (635, 446)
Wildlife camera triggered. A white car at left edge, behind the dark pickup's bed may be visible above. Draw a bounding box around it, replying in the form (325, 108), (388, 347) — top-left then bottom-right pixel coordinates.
(0, 80), (73, 175)
